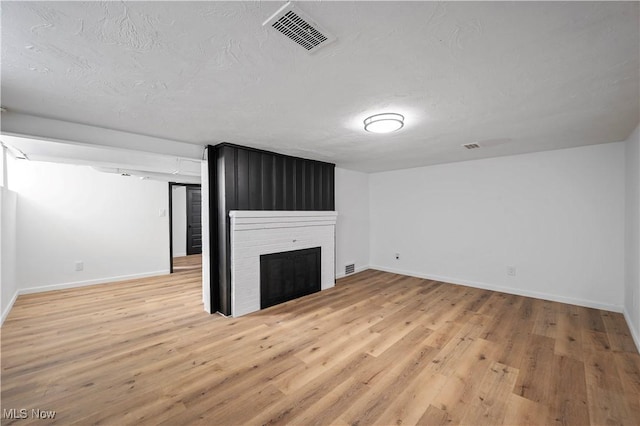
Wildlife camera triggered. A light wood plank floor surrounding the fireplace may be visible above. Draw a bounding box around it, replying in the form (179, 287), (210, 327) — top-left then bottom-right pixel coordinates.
(1, 271), (640, 425)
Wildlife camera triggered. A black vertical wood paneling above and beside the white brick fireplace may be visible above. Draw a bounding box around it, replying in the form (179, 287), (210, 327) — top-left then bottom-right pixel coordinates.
(207, 143), (335, 315)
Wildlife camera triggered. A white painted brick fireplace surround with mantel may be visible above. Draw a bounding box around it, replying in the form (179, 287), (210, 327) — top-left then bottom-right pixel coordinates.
(229, 210), (338, 317)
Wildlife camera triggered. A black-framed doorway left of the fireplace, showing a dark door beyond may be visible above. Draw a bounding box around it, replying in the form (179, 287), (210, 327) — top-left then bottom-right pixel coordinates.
(169, 182), (202, 273)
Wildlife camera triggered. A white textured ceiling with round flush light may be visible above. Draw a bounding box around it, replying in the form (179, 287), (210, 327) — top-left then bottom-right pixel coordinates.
(1, 2), (640, 171)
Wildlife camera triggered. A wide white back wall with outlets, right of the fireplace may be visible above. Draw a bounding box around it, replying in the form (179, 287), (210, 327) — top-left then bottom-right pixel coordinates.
(369, 143), (625, 311)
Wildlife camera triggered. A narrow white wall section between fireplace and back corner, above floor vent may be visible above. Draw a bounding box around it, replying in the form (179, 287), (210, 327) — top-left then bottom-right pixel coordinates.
(335, 168), (369, 278)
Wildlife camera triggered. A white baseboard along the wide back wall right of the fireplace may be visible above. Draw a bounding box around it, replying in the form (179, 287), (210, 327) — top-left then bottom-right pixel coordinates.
(371, 265), (623, 312)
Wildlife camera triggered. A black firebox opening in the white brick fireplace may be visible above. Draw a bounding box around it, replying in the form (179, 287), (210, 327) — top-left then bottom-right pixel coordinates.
(260, 247), (321, 309)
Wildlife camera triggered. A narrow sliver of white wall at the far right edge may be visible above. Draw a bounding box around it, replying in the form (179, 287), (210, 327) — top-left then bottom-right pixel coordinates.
(624, 126), (640, 351)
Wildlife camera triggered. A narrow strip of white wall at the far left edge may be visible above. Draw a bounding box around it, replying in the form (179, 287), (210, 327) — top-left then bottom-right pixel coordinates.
(0, 187), (18, 324)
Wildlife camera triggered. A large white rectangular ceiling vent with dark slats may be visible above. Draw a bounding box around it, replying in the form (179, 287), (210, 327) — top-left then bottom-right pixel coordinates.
(262, 2), (336, 53)
